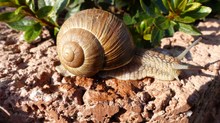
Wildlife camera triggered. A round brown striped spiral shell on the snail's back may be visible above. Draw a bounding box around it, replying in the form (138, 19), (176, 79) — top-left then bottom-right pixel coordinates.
(57, 9), (134, 76)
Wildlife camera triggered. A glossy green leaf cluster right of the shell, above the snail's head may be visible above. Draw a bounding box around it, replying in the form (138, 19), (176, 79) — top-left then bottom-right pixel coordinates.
(123, 0), (211, 46)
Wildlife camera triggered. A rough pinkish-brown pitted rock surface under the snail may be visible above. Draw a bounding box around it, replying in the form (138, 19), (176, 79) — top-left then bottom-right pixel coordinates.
(0, 19), (220, 123)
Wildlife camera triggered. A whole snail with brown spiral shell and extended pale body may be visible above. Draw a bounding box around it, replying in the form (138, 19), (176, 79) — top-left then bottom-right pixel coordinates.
(57, 9), (201, 80)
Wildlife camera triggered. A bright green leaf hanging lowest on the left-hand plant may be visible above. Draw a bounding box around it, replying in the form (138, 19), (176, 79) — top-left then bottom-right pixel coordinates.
(24, 23), (42, 43)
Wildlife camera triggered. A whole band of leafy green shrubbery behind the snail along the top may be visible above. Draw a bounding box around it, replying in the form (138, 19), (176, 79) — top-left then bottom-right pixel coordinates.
(0, 0), (217, 47)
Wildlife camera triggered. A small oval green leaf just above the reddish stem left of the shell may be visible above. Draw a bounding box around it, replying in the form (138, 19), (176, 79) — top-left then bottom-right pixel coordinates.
(36, 6), (53, 19)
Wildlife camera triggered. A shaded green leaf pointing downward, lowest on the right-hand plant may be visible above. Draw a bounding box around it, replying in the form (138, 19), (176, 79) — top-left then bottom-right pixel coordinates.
(151, 27), (164, 46)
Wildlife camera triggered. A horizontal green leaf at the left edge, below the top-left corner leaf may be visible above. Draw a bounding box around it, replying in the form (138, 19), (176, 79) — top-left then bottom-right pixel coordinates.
(0, 12), (24, 23)
